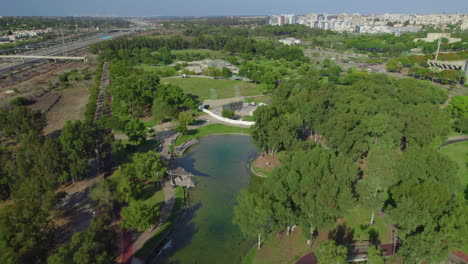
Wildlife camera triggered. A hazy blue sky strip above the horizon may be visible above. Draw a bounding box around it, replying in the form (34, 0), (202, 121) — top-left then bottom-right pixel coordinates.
(0, 0), (468, 16)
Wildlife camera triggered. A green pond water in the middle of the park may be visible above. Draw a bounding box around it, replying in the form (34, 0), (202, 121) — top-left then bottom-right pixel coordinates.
(154, 135), (257, 264)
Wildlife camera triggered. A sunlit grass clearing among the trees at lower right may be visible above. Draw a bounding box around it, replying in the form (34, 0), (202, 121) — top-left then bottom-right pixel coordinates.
(344, 205), (392, 244)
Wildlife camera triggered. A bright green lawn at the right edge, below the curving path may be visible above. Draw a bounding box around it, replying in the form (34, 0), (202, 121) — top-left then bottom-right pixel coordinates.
(440, 141), (468, 194)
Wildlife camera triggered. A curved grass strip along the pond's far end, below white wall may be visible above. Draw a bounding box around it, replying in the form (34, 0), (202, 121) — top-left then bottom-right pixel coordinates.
(175, 124), (250, 146)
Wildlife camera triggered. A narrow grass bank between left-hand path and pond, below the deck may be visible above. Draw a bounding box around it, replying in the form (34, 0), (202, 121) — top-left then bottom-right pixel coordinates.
(135, 186), (185, 259)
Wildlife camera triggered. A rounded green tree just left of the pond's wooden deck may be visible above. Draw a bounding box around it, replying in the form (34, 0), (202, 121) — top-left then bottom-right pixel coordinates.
(133, 150), (167, 182)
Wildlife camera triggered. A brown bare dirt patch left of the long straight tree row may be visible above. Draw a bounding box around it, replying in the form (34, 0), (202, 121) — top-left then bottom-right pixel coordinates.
(44, 85), (89, 135)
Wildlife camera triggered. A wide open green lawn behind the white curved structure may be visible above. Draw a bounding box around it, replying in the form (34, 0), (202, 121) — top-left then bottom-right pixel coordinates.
(161, 77), (262, 102)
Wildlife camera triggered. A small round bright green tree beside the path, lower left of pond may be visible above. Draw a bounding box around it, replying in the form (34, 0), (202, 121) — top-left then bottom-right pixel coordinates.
(120, 200), (158, 230)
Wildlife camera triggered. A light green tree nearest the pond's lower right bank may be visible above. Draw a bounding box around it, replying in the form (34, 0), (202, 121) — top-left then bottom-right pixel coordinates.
(233, 191), (273, 249)
